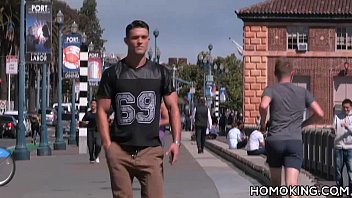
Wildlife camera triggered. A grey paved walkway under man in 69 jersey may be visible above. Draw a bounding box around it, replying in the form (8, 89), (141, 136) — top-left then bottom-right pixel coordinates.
(0, 132), (258, 198)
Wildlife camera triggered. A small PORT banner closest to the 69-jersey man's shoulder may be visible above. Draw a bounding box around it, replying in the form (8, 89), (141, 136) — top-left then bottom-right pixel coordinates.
(88, 52), (102, 86)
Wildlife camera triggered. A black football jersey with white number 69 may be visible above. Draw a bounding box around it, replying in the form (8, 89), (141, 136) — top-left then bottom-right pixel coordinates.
(97, 59), (175, 146)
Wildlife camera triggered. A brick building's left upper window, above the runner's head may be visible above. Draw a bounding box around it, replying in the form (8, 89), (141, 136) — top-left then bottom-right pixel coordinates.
(287, 26), (308, 50)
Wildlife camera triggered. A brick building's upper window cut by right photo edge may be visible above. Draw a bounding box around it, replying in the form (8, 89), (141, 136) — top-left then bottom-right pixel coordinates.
(336, 27), (352, 50)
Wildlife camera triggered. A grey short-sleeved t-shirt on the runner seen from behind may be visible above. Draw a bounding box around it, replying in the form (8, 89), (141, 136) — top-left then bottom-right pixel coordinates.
(263, 83), (314, 140)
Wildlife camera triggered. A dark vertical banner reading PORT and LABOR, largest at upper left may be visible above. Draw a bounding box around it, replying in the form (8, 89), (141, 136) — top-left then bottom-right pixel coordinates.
(26, 1), (52, 64)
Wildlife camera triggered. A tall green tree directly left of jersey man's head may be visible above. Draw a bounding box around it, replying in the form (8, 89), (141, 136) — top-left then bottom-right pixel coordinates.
(79, 0), (105, 49)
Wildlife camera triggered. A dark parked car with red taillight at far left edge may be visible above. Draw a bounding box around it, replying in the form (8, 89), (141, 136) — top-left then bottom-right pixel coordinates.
(0, 115), (17, 138)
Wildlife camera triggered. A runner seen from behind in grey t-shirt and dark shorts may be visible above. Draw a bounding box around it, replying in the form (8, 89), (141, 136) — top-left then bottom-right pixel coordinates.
(259, 59), (324, 197)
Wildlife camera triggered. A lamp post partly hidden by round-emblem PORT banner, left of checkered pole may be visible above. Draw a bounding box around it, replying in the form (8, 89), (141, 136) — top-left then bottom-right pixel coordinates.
(68, 22), (78, 144)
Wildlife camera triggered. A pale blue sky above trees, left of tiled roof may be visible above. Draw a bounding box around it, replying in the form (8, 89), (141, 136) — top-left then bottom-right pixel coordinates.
(63, 0), (263, 64)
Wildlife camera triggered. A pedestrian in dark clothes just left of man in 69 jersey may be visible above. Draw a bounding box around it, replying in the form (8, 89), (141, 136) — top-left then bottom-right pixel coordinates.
(82, 99), (101, 163)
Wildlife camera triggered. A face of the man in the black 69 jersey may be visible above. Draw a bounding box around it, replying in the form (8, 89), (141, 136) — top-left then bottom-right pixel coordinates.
(125, 28), (149, 55)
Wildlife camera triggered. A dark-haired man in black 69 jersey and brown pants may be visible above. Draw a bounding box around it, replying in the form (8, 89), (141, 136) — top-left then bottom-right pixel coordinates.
(97, 20), (181, 198)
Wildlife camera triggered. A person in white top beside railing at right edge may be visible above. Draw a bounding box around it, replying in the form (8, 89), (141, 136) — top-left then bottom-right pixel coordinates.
(333, 99), (352, 192)
